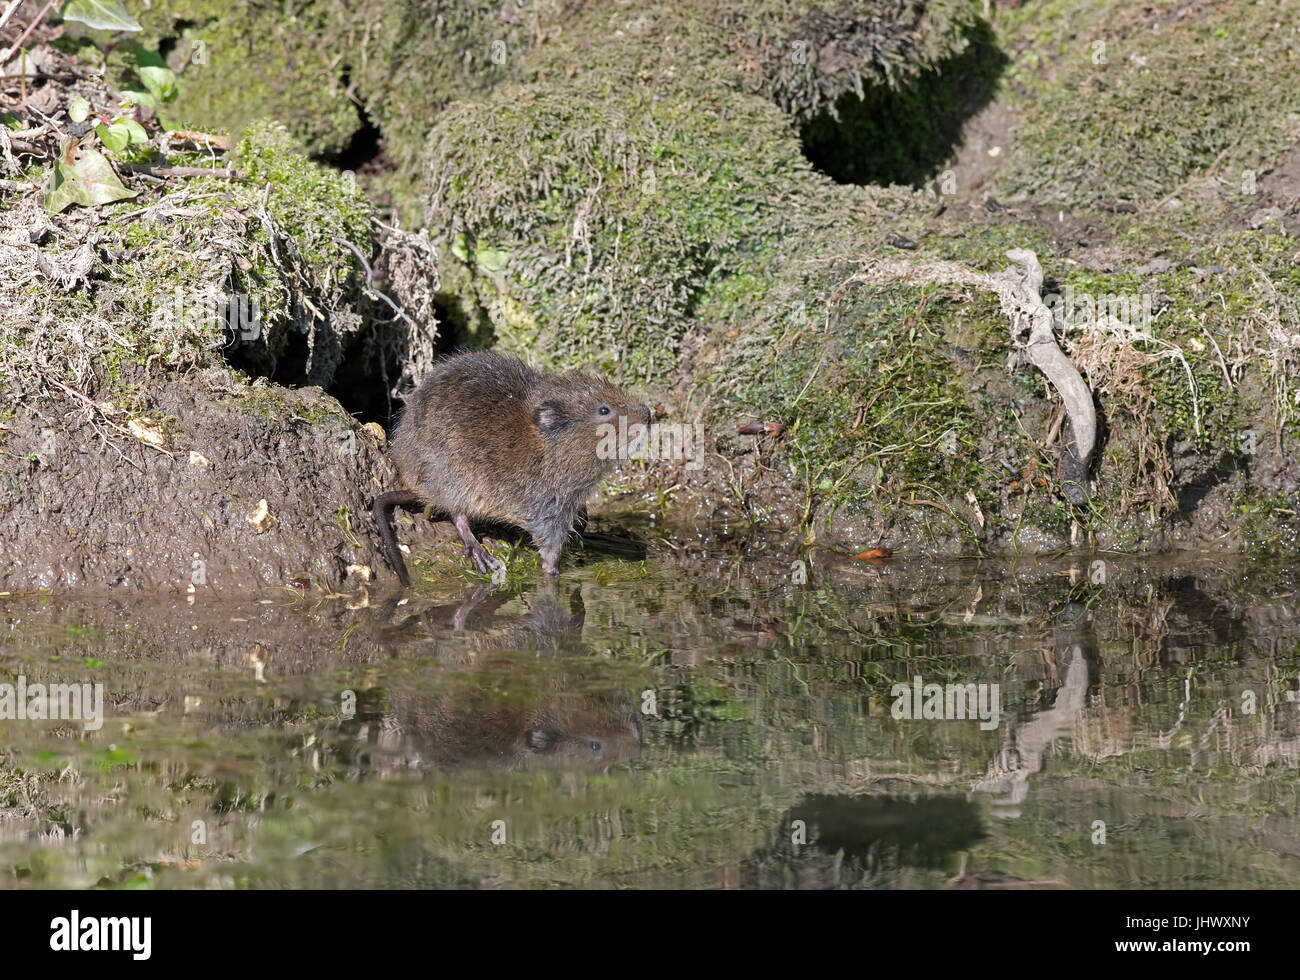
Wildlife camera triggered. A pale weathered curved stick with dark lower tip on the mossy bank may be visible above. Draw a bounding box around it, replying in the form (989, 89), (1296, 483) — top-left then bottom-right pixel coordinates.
(996, 248), (1097, 504)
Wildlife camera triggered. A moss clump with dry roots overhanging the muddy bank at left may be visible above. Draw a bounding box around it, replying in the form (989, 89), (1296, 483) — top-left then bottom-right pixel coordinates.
(3, 123), (372, 408)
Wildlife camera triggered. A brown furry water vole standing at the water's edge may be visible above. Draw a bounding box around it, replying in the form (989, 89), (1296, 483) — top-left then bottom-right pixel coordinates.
(374, 352), (650, 585)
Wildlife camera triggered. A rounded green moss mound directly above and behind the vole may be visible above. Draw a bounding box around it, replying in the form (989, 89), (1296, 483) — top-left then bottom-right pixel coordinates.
(426, 58), (811, 378)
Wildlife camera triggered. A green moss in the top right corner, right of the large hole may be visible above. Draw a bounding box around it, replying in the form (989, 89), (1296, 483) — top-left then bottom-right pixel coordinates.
(998, 0), (1300, 207)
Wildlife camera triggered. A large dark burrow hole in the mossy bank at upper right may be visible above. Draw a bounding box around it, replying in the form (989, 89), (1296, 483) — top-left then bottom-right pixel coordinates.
(801, 22), (1009, 187)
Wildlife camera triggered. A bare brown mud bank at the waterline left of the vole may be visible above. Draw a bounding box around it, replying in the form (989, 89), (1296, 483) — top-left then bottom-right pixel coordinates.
(0, 376), (452, 594)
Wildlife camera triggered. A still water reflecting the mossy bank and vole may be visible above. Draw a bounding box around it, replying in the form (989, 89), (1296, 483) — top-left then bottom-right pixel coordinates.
(0, 542), (1300, 888)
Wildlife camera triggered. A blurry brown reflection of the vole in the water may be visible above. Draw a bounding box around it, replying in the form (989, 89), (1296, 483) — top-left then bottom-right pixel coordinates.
(356, 585), (641, 771)
